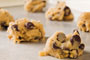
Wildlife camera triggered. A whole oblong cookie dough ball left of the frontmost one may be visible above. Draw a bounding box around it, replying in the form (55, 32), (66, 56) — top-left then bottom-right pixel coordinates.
(8, 18), (45, 43)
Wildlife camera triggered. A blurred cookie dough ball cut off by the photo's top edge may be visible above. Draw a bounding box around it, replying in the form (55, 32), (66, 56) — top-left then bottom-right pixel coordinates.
(24, 0), (46, 12)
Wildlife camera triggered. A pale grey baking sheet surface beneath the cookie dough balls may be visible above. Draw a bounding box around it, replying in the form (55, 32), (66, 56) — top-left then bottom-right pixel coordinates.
(0, 6), (90, 60)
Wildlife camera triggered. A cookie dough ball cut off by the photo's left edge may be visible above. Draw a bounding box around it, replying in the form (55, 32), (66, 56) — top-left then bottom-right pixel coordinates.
(0, 8), (14, 30)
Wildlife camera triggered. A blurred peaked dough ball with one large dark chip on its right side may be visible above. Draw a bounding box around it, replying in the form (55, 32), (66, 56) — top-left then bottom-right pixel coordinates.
(45, 2), (74, 21)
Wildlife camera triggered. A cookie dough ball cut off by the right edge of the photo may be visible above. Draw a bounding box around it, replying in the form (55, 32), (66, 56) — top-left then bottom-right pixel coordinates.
(77, 12), (90, 32)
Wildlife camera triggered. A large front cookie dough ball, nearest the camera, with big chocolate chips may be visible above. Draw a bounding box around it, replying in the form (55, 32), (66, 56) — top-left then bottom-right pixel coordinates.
(39, 30), (85, 59)
